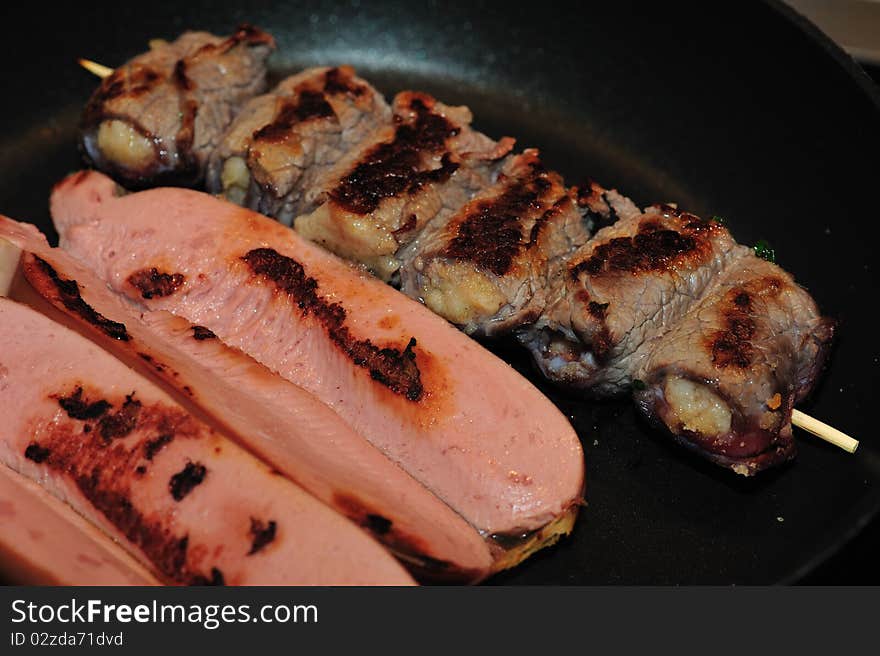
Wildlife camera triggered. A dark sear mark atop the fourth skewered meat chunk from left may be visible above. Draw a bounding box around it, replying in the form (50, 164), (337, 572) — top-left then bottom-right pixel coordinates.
(442, 166), (552, 276)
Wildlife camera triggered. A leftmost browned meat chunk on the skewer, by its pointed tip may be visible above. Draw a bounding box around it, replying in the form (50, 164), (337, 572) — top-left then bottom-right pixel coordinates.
(81, 26), (274, 187)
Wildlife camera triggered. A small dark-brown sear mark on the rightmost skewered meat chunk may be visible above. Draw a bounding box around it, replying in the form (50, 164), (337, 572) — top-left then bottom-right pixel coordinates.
(708, 276), (785, 369)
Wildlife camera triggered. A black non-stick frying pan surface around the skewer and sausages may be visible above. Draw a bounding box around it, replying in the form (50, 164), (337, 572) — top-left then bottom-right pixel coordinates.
(0, 0), (880, 584)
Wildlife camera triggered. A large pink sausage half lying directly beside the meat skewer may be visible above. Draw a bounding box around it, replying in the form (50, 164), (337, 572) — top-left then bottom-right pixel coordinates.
(51, 172), (584, 566)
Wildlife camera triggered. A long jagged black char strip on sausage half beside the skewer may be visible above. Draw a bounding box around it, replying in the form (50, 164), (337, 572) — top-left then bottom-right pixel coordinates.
(241, 248), (425, 401)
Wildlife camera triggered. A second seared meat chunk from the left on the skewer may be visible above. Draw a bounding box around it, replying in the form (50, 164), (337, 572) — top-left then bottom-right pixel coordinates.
(207, 66), (391, 225)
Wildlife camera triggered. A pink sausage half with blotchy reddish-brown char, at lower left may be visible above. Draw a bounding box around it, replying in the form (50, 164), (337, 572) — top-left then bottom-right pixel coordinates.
(0, 298), (412, 585)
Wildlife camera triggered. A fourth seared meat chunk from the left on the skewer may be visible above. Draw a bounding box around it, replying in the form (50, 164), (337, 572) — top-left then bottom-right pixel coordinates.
(399, 150), (589, 335)
